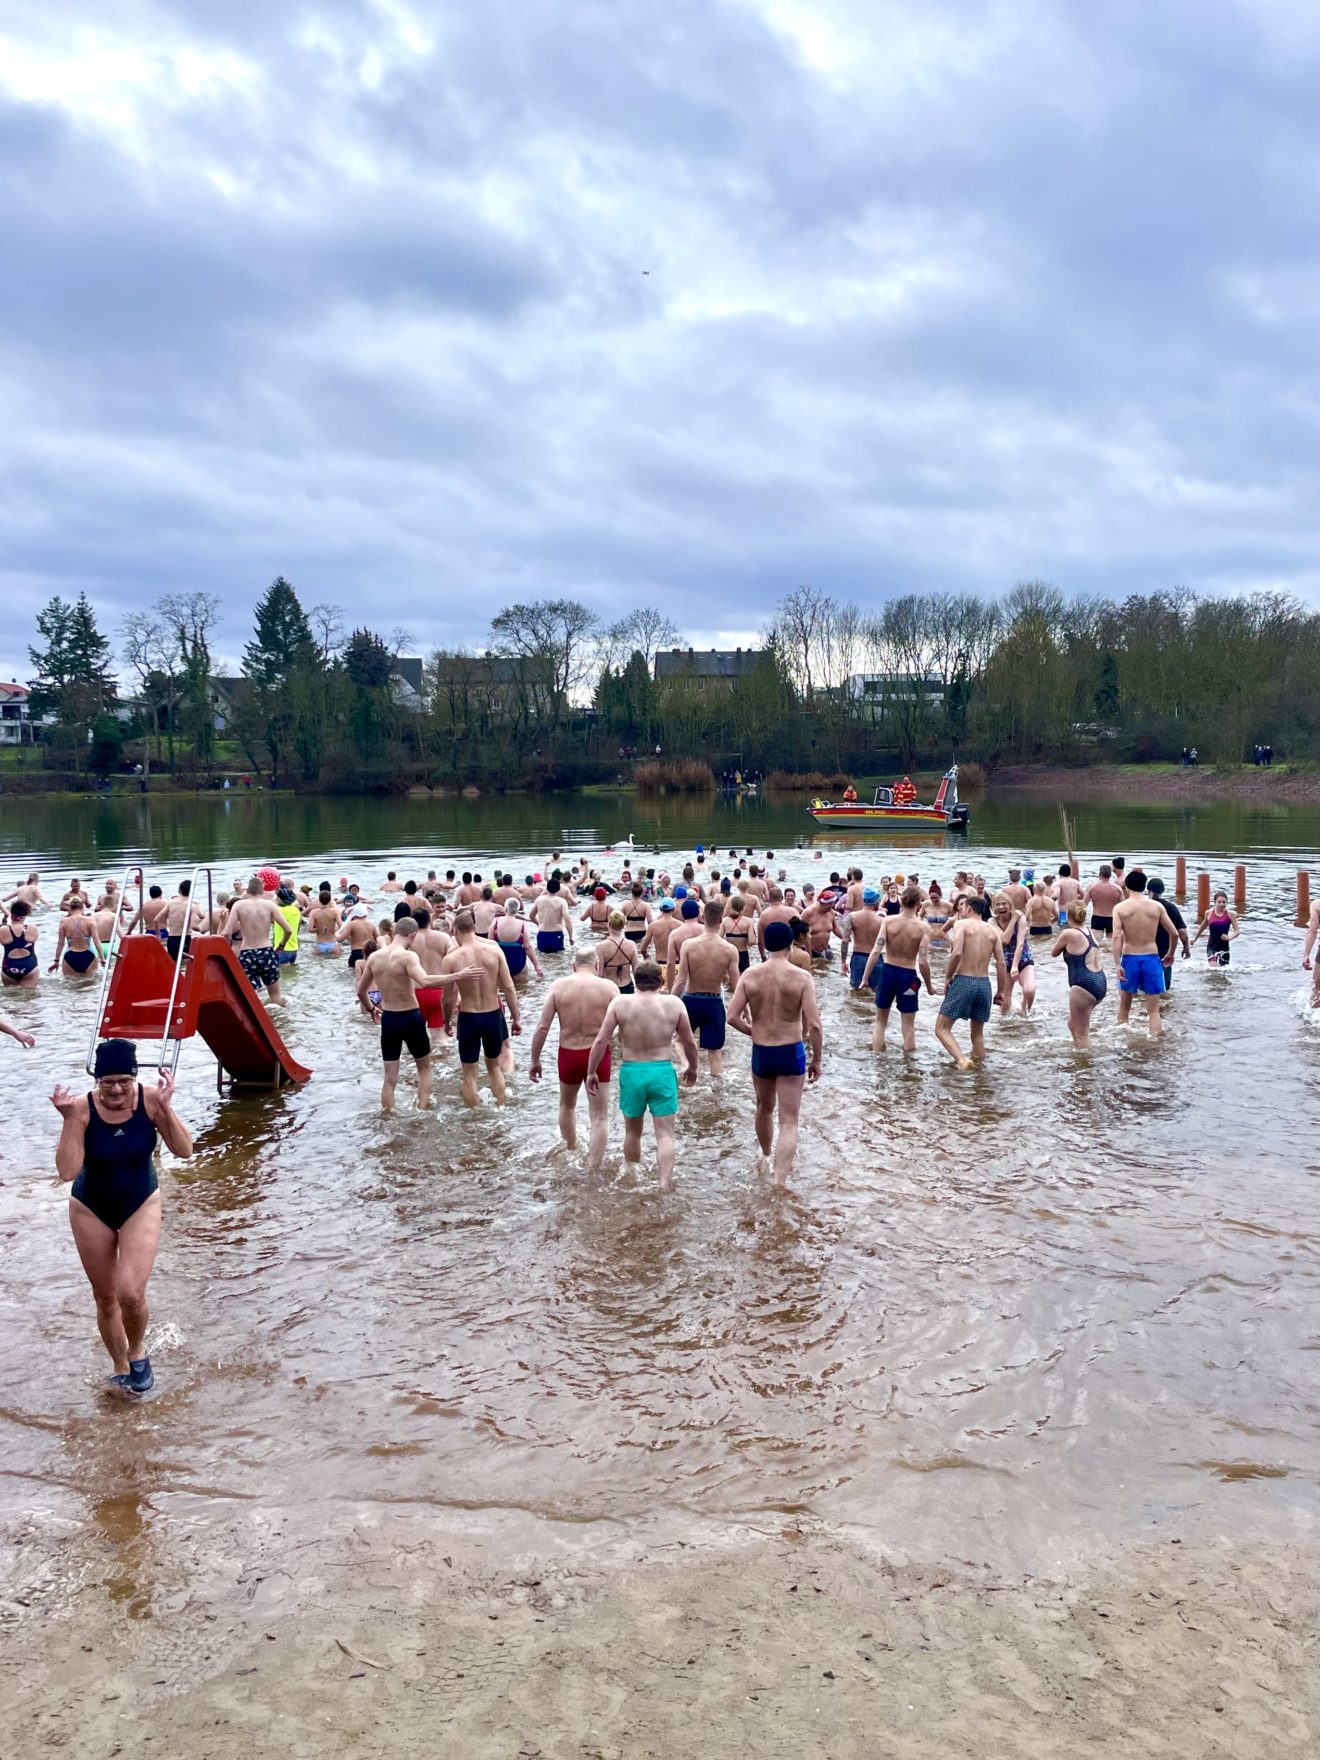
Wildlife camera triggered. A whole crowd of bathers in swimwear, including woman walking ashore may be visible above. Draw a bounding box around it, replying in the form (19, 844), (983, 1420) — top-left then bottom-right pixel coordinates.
(0, 848), (1320, 1397)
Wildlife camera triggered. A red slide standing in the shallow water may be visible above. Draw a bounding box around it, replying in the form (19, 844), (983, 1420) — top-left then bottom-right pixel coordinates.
(100, 935), (312, 1088)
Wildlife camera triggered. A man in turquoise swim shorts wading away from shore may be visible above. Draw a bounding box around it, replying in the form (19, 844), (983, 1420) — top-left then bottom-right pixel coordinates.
(586, 959), (697, 1192)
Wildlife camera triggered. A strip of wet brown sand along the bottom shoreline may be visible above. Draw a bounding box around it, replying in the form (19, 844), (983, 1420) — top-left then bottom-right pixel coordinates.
(5, 1522), (1320, 1760)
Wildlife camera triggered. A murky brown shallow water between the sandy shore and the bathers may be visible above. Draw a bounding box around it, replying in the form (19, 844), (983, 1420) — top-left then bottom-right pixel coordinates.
(0, 806), (1320, 1640)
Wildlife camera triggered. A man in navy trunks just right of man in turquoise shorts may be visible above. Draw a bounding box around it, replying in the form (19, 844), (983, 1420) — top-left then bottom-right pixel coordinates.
(729, 922), (822, 1186)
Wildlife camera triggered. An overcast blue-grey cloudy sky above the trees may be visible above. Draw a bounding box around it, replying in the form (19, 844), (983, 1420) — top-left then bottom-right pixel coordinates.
(0, 0), (1318, 678)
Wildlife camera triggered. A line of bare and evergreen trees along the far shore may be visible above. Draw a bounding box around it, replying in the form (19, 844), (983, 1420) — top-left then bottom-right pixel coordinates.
(20, 577), (1320, 790)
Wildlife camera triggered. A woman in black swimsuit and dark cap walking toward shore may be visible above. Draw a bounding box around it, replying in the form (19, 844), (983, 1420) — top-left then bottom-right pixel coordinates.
(51, 1038), (192, 1397)
